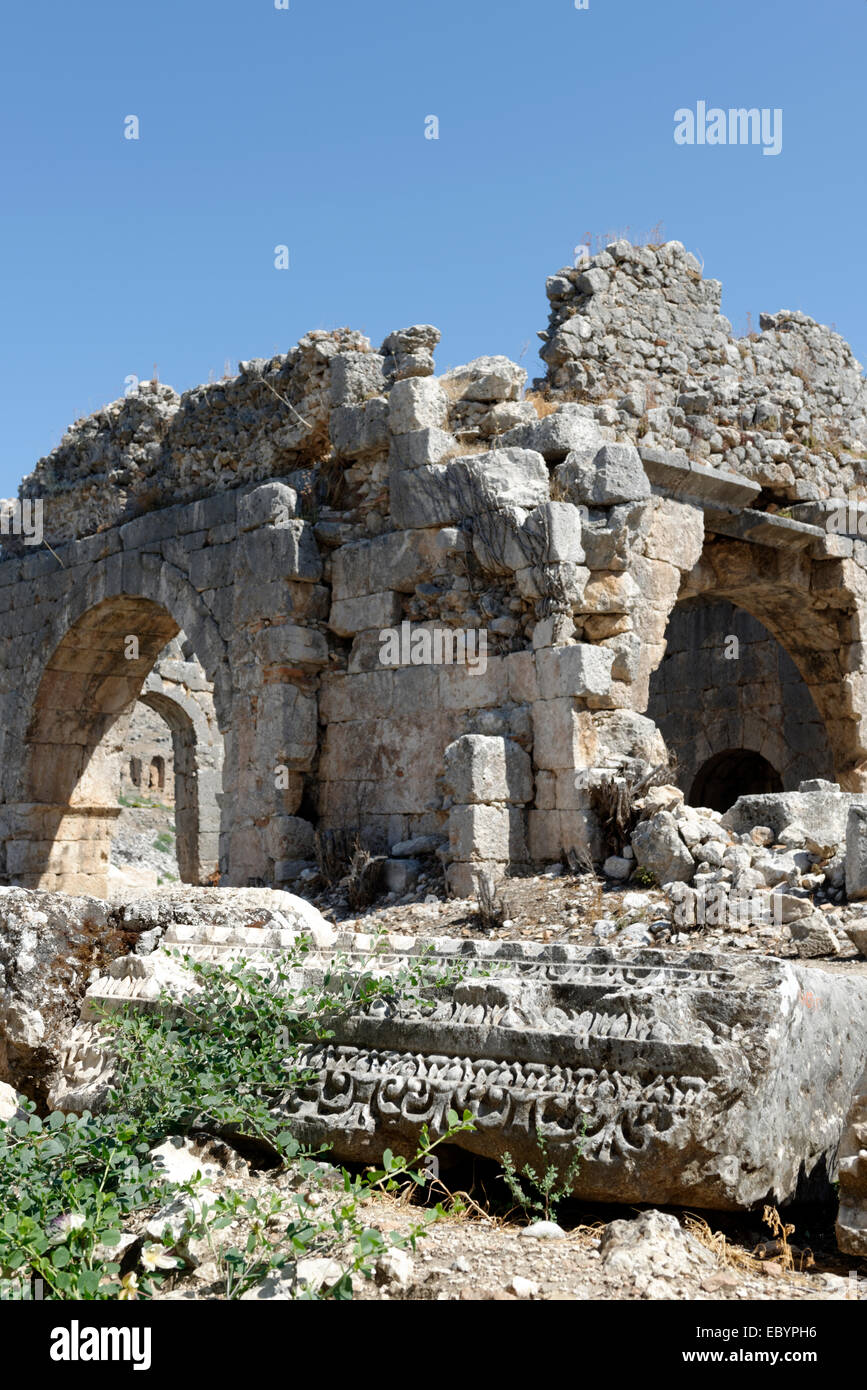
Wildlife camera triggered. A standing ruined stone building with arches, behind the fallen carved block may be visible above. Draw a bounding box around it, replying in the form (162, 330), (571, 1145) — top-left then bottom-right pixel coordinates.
(0, 243), (867, 892)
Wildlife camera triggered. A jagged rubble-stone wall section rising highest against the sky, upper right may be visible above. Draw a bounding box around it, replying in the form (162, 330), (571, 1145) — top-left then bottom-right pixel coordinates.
(542, 242), (867, 503)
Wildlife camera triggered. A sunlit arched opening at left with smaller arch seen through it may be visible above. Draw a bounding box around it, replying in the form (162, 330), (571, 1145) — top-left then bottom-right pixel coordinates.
(18, 595), (222, 897)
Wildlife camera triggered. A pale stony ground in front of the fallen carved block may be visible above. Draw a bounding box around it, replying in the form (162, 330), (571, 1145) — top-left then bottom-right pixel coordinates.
(131, 1143), (867, 1302)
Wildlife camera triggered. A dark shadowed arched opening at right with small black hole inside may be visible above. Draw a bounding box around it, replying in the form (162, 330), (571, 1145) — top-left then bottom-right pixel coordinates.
(647, 595), (835, 810)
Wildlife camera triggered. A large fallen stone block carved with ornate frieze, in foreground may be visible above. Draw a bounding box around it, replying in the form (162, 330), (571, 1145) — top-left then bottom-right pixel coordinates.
(67, 927), (867, 1209)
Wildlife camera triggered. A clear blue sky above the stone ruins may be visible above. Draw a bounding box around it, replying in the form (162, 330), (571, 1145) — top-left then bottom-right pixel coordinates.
(0, 0), (867, 496)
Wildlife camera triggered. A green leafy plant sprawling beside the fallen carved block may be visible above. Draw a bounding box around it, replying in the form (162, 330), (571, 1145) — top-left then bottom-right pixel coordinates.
(0, 940), (472, 1300)
